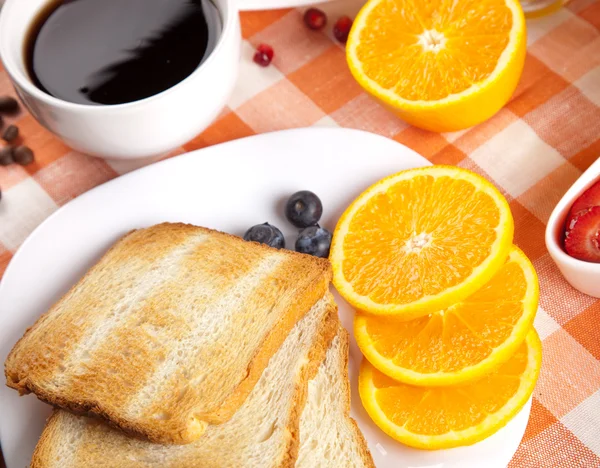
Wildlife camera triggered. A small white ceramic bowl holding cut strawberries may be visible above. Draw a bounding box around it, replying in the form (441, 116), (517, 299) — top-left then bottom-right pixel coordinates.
(546, 159), (600, 297)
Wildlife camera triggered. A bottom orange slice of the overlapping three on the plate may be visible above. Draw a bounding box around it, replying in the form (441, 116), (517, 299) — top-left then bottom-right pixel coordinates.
(358, 329), (542, 450)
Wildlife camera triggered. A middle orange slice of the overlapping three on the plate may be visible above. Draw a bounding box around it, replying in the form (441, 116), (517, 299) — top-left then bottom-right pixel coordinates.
(354, 247), (539, 386)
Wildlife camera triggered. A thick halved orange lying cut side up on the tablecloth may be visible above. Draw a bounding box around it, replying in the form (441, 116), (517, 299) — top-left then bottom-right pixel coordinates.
(346, 0), (526, 132)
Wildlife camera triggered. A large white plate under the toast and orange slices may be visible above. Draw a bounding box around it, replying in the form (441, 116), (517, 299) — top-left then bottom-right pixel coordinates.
(0, 128), (529, 468)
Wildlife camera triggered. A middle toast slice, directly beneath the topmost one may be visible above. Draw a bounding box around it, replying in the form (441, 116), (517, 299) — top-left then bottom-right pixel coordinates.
(31, 293), (339, 468)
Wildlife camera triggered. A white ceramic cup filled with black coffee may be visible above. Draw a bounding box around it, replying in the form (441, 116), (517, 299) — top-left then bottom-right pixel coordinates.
(0, 0), (241, 159)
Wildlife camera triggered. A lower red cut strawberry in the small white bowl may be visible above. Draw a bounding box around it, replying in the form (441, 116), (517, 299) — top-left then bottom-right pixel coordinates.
(565, 206), (600, 263)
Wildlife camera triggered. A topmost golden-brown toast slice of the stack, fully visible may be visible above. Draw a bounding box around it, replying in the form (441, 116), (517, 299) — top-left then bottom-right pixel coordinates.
(5, 223), (331, 444)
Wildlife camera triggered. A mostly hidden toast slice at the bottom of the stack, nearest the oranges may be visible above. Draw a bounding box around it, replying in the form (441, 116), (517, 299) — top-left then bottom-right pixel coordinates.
(296, 325), (375, 468)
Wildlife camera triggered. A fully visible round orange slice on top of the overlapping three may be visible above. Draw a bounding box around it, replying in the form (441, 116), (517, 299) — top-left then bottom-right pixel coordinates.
(329, 166), (514, 319)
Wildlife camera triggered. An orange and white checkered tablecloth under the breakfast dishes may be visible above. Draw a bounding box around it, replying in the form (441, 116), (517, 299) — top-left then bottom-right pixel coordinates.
(0, 0), (600, 468)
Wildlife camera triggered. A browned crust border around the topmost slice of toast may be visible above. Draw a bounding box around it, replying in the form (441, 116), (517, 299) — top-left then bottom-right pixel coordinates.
(5, 223), (331, 444)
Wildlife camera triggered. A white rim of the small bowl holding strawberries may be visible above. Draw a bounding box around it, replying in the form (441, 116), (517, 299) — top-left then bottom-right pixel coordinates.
(545, 158), (600, 275)
